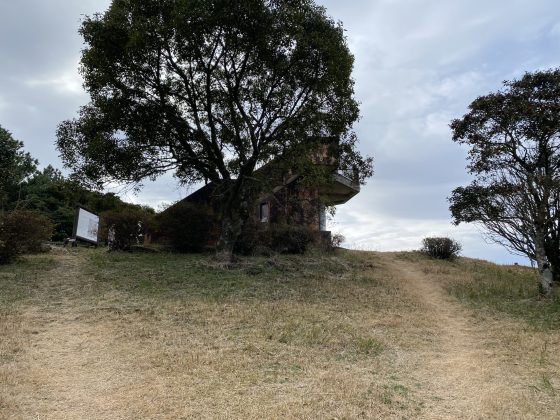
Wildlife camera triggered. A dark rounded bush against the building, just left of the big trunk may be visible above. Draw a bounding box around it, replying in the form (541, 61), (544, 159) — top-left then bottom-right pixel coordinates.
(157, 202), (217, 252)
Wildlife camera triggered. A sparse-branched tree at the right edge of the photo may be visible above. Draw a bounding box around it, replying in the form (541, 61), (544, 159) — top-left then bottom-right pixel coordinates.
(449, 69), (560, 295)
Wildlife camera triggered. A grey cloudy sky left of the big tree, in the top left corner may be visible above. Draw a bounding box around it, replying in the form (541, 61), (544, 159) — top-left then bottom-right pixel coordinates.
(0, 0), (109, 166)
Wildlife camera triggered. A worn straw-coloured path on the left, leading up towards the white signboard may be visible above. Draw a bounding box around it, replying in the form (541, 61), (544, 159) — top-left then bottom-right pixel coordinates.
(14, 250), (142, 419)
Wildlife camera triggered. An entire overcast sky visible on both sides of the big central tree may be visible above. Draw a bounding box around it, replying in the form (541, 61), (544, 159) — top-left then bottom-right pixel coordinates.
(0, 0), (560, 263)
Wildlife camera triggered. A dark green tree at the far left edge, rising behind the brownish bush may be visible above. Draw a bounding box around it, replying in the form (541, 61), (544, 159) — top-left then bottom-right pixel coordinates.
(0, 126), (37, 211)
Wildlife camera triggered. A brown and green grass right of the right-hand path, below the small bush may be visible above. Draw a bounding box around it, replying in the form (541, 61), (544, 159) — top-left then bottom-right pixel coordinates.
(394, 249), (560, 418)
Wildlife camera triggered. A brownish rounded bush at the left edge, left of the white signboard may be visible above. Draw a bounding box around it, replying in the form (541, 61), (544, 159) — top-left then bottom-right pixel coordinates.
(0, 210), (53, 264)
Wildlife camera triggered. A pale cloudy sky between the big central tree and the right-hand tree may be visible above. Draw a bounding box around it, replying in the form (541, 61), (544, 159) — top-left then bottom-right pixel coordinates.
(322, 0), (560, 262)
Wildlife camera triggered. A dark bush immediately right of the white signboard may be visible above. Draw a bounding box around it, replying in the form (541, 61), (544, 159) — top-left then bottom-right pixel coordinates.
(100, 208), (153, 251)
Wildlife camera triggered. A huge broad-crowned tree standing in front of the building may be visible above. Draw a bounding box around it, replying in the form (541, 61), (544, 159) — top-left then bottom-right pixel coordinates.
(58, 0), (372, 258)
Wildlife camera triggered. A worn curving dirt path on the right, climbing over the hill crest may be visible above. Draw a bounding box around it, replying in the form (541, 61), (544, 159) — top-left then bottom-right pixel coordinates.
(379, 253), (504, 418)
